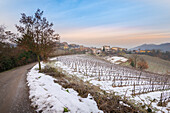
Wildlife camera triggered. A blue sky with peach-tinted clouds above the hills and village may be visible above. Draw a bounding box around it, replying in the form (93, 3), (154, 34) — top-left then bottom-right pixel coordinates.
(0, 0), (170, 48)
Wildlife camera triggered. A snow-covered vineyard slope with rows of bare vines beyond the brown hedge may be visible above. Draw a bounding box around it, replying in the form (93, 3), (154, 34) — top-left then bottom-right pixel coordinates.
(51, 55), (170, 112)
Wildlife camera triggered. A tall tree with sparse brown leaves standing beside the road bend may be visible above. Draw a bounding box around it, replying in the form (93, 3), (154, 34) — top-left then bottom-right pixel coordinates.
(15, 9), (59, 70)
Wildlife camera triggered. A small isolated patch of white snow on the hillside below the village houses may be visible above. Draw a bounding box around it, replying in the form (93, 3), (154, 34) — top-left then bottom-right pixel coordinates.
(104, 56), (128, 64)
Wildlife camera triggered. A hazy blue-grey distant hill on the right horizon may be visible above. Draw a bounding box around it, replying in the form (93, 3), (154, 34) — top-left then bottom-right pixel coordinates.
(130, 43), (170, 51)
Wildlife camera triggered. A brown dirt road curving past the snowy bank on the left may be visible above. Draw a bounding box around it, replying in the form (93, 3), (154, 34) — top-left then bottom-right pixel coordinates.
(0, 63), (35, 113)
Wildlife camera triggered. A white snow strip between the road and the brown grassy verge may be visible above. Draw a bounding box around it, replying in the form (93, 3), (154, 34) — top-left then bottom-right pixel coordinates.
(27, 64), (102, 113)
